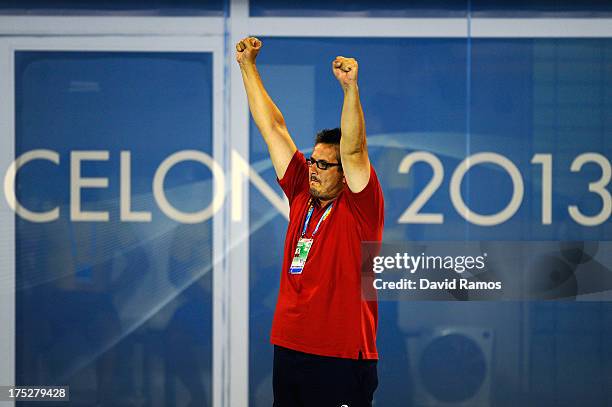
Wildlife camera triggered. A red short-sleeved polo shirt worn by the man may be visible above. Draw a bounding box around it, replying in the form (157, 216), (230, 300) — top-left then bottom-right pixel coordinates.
(270, 151), (384, 359)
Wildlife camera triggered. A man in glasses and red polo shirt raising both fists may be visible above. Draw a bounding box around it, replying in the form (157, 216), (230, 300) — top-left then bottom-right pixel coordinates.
(236, 37), (384, 407)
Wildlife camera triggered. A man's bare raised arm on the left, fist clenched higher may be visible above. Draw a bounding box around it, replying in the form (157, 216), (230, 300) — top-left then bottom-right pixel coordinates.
(236, 37), (297, 179)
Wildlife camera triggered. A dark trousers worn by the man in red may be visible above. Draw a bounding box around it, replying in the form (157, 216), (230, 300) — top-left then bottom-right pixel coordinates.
(273, 346), (378, 407)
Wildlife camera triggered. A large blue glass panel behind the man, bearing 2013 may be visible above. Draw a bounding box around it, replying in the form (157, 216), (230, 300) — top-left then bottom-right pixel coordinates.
(249, 38), (612, 407)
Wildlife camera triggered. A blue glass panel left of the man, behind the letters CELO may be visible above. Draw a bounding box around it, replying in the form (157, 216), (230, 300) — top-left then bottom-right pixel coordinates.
(15, 51), (213, 406)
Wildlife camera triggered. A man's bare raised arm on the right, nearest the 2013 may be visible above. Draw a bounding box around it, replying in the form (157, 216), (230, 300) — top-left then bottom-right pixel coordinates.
(332, 56), (370, 192)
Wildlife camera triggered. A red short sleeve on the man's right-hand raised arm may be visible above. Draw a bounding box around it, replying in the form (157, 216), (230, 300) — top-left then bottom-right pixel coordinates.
(345, 165), (385, 240)
